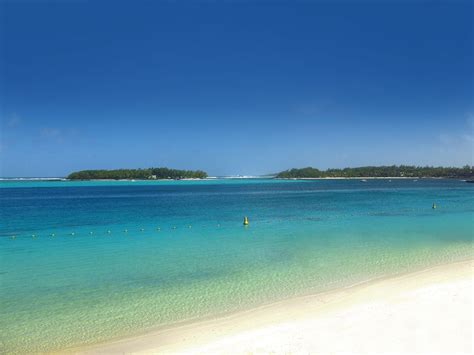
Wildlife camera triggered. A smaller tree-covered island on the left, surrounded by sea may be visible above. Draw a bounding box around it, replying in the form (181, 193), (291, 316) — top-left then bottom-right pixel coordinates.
(67, 168), (207, 180)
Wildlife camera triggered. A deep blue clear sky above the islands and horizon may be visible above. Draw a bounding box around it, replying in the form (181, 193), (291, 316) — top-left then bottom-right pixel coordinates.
(0, 0), (474, 176)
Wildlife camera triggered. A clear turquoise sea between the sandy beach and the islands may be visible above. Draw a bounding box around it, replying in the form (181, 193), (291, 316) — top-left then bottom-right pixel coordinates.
(0, 179), (474, 353)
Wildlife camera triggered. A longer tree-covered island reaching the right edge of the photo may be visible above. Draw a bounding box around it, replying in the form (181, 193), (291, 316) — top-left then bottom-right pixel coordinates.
(275, 165), (474, 179)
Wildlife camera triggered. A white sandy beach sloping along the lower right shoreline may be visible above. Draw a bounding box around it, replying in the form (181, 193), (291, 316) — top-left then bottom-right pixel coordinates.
(76, 261), (474, 354)
